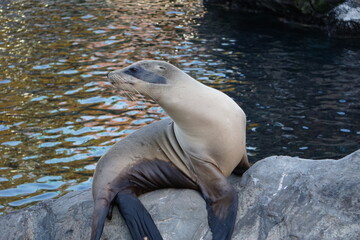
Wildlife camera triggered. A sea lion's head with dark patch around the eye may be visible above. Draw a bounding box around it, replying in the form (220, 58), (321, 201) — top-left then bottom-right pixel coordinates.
(108, 60), (186, 100)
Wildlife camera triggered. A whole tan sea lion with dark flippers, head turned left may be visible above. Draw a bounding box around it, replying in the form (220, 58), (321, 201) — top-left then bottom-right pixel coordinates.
(91, 60), (249, 240)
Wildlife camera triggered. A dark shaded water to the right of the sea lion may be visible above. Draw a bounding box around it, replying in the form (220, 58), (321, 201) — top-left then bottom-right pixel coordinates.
(201, 9), (360, 161)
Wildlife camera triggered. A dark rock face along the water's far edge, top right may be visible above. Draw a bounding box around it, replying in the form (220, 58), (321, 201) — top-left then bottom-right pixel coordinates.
(204, 0), (360, 38)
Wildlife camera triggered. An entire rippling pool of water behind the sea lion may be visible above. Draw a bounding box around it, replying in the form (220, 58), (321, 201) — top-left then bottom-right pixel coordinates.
(0, 0), (360, 212)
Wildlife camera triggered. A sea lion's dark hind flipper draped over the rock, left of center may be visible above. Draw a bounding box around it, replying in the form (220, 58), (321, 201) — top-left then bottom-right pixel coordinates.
(115, 193), (162, 240)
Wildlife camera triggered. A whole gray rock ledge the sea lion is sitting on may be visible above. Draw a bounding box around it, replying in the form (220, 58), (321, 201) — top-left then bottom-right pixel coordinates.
(0, 150), (360, 240)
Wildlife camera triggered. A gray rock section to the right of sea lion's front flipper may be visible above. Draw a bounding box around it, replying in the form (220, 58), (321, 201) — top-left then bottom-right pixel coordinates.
(234, 150), (360, 240)
